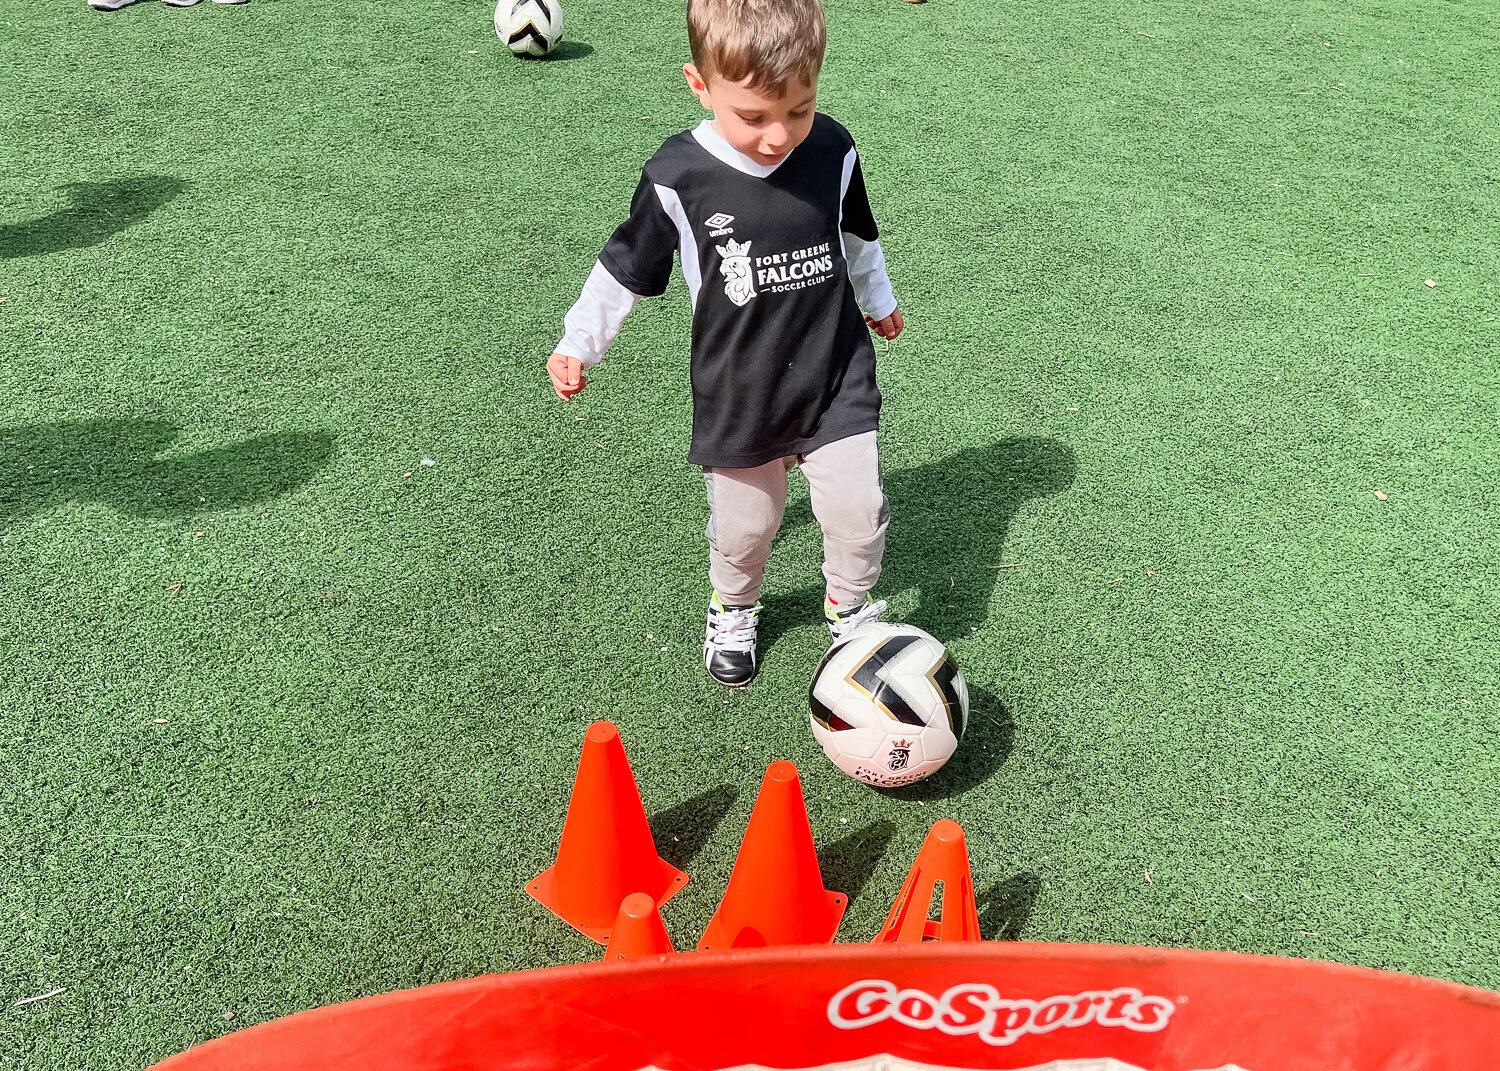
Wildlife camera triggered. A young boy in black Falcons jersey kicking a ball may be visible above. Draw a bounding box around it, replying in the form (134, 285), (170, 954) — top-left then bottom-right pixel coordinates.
(548, 0), (902, 687)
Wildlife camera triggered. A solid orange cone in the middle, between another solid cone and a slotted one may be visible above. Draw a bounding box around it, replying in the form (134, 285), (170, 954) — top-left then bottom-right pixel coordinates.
(698, 762), (849, 953)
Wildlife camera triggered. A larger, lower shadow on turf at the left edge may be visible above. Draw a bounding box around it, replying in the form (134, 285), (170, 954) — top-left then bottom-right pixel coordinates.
(0, 419), (333, 528)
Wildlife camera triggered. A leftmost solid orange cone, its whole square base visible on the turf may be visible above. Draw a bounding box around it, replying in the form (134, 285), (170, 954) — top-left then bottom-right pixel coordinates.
(527, 722), (687, 944)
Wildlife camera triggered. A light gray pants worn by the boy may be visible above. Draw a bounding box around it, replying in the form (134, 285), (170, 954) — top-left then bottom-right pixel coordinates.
(704, 432), (891, 606)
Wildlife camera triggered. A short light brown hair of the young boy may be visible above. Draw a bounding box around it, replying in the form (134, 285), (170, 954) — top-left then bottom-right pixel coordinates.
(687, 0), (828, 96)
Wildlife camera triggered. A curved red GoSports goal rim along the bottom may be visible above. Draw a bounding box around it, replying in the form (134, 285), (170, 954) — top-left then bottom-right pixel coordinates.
(158, 942), (1500, 1071)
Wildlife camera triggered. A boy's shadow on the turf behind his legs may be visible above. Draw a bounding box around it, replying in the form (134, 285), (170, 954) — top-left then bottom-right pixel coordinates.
(762, 437), (1077, 650)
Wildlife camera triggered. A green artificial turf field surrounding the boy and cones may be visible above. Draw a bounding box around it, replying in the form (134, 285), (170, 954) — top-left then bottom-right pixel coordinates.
(0, 0), (1500, 1071)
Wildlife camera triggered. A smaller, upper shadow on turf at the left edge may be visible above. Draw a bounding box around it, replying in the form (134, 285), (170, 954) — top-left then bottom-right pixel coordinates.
(0, 176), (188, 260)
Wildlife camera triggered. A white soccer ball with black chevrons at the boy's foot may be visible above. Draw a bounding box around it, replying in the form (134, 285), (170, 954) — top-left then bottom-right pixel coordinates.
(807, 621), (969, 788)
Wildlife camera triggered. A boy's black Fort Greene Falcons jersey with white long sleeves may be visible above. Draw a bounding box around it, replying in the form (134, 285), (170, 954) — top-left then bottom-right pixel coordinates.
(558, 114), (896, 468)
